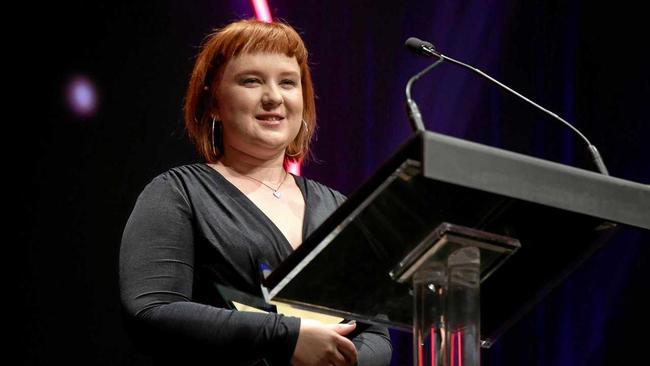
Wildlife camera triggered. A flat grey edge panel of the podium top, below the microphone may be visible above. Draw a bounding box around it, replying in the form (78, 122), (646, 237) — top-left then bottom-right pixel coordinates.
(422, 132), (650, 230)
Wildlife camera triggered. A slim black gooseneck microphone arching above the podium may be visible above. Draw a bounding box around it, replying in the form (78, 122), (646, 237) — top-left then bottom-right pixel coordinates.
(404, 37), (609, 175)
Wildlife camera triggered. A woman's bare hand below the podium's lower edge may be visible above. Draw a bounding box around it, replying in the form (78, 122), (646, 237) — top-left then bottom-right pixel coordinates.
(291, 319), (357, 366)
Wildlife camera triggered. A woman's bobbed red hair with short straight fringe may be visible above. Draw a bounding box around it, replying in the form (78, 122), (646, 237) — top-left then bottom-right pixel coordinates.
(183, 19), (316, 163)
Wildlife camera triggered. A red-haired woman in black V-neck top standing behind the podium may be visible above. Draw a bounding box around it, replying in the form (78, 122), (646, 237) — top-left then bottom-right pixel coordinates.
(120, 20), (391, 365)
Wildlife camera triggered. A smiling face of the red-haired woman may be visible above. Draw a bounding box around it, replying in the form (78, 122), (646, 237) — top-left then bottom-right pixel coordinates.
(216, 53), (303, 158)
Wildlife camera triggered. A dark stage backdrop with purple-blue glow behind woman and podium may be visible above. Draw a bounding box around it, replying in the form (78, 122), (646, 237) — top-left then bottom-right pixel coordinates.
(21, 0), (650, 365)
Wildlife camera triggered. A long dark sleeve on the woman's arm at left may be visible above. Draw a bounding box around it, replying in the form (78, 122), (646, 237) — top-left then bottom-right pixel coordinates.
(119, 175), (300, 364)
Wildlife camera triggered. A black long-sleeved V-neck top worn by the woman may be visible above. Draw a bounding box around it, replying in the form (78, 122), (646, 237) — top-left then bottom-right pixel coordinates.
(119, 164), (391, 365)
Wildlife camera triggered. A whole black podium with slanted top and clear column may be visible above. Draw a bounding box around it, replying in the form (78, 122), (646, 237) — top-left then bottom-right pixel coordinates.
(262, 131), (650, 365)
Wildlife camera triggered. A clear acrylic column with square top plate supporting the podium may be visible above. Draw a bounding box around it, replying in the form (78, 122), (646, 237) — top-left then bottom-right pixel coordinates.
(390, 223), (519, 366)
